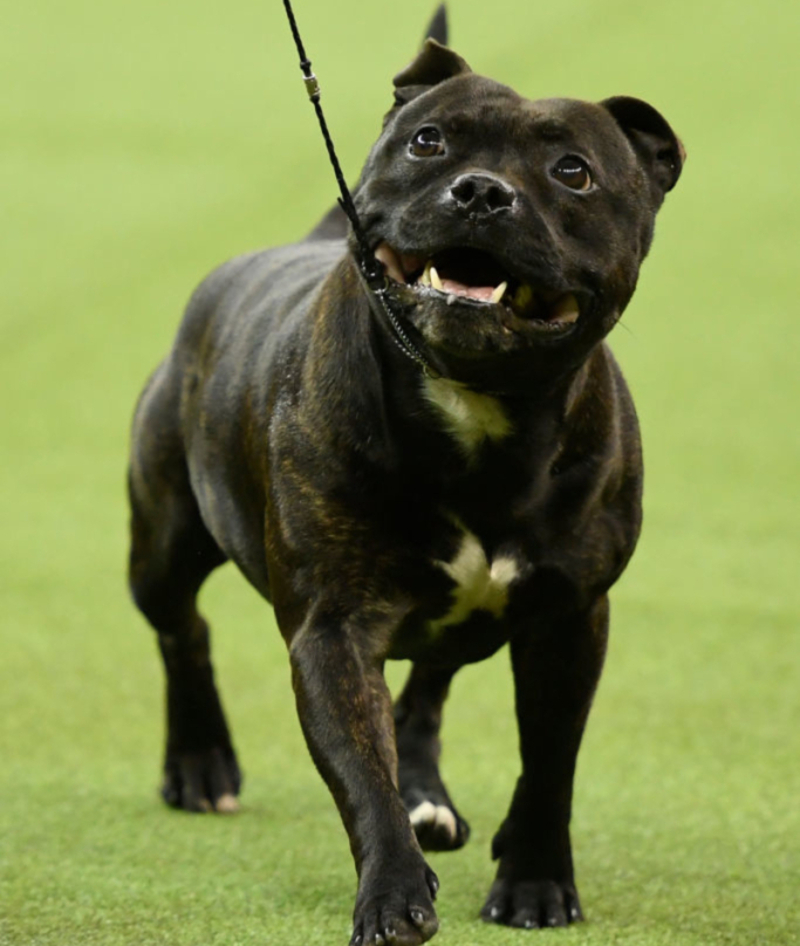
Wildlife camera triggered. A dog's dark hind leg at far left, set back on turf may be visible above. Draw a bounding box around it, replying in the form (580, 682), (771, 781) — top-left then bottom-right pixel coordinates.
(129, 362), (241, 811)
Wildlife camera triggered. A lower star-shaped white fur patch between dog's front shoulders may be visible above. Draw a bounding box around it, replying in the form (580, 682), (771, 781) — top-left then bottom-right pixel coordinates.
(430, 529), (519, 634)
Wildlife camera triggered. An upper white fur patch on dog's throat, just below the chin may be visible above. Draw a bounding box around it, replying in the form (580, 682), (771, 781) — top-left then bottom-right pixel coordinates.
(424, 378), (511, 459)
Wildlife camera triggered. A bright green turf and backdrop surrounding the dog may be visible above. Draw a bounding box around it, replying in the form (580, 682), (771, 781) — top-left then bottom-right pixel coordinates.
(0, 0), (800, 946)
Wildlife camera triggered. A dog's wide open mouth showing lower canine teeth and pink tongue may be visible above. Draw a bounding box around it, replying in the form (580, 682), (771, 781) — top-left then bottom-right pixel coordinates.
(375, 242), (581, 328)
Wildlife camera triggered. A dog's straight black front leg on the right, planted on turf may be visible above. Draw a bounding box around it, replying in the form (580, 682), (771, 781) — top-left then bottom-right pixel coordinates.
(481, 595), (608, 929)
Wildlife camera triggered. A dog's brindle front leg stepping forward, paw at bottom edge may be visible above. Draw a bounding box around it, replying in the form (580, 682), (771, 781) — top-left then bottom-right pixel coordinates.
(290, 622), (439, 946)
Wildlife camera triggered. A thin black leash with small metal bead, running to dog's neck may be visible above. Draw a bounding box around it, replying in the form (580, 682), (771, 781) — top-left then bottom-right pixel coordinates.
(283, 0), (440, 378)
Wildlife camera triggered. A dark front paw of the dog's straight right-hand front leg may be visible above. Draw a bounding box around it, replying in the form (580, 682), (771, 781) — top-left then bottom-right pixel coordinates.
(481, 879), (583, 930)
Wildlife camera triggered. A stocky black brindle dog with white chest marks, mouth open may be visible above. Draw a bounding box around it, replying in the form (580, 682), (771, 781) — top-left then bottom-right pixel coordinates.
(129, 13), (685, 946)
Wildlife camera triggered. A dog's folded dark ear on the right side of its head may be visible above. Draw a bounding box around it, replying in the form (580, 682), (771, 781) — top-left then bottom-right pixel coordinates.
(600, 95), (686, 197)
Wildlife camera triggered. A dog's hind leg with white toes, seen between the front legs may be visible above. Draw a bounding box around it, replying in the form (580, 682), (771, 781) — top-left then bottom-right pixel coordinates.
(394, 663), (469, 851)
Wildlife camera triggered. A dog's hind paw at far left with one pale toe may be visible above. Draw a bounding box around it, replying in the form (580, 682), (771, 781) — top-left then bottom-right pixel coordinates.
(161, 748), (242, 814)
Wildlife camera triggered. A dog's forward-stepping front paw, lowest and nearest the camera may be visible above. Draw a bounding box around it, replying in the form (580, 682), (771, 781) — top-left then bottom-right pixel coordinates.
(350, 862), (439, 946)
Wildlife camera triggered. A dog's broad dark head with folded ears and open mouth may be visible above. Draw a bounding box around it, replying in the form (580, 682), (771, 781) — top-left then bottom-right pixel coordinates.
(356, 40), (683, 388)
